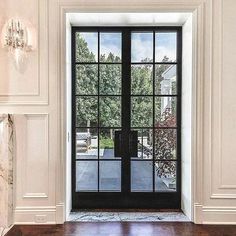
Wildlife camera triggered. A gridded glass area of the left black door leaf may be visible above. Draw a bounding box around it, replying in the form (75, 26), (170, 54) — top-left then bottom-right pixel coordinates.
(74, 31), (122, 193)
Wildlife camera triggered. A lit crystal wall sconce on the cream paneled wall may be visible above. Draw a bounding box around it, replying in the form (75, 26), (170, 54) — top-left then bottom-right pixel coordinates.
(1, 18), (36, 72)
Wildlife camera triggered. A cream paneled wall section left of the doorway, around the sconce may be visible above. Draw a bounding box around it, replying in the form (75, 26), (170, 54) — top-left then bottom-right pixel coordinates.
(0, 0), (60, 223)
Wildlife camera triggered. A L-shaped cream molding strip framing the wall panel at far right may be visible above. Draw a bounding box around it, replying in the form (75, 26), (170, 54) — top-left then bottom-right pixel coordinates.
(210, 0), (236, 195)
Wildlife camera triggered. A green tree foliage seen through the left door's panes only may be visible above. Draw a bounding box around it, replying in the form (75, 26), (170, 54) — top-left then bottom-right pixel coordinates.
(76, 33), (121, 130)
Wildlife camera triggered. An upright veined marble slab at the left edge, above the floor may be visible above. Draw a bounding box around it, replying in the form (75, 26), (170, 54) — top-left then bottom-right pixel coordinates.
(0, 114), (14, 229)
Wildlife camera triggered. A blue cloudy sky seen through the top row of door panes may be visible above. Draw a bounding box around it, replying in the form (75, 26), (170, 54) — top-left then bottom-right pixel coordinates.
(81, 32), (176, 62)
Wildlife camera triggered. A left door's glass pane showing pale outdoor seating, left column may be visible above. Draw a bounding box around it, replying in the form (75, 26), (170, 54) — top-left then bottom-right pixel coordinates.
(76, 128), (98, 159)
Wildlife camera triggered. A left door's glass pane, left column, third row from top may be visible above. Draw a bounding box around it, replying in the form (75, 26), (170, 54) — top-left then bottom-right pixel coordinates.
(76, 97), (98, 127)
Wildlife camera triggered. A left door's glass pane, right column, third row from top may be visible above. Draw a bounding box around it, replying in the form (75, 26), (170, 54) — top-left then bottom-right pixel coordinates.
(99, 96), (121, 127)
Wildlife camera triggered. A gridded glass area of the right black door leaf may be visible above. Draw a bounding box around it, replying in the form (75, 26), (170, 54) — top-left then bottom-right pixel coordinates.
(130, 31), (178, 192)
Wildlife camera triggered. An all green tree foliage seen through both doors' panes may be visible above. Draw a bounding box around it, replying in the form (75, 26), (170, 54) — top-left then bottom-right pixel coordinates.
(76, 33), (175, 142)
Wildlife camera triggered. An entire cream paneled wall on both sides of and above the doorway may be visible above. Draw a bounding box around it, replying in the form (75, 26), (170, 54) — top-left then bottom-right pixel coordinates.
(0, 0), (236, 224)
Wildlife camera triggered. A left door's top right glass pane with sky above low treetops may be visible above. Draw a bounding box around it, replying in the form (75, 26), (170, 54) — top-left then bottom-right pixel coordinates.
(100, 33), (121, 62)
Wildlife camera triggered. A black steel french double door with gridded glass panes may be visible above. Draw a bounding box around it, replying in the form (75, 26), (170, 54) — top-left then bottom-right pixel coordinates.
(72, 27), (182, 209)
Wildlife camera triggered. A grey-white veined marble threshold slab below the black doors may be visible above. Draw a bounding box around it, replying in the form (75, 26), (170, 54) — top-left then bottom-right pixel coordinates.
(67, 211), (190, 222)
